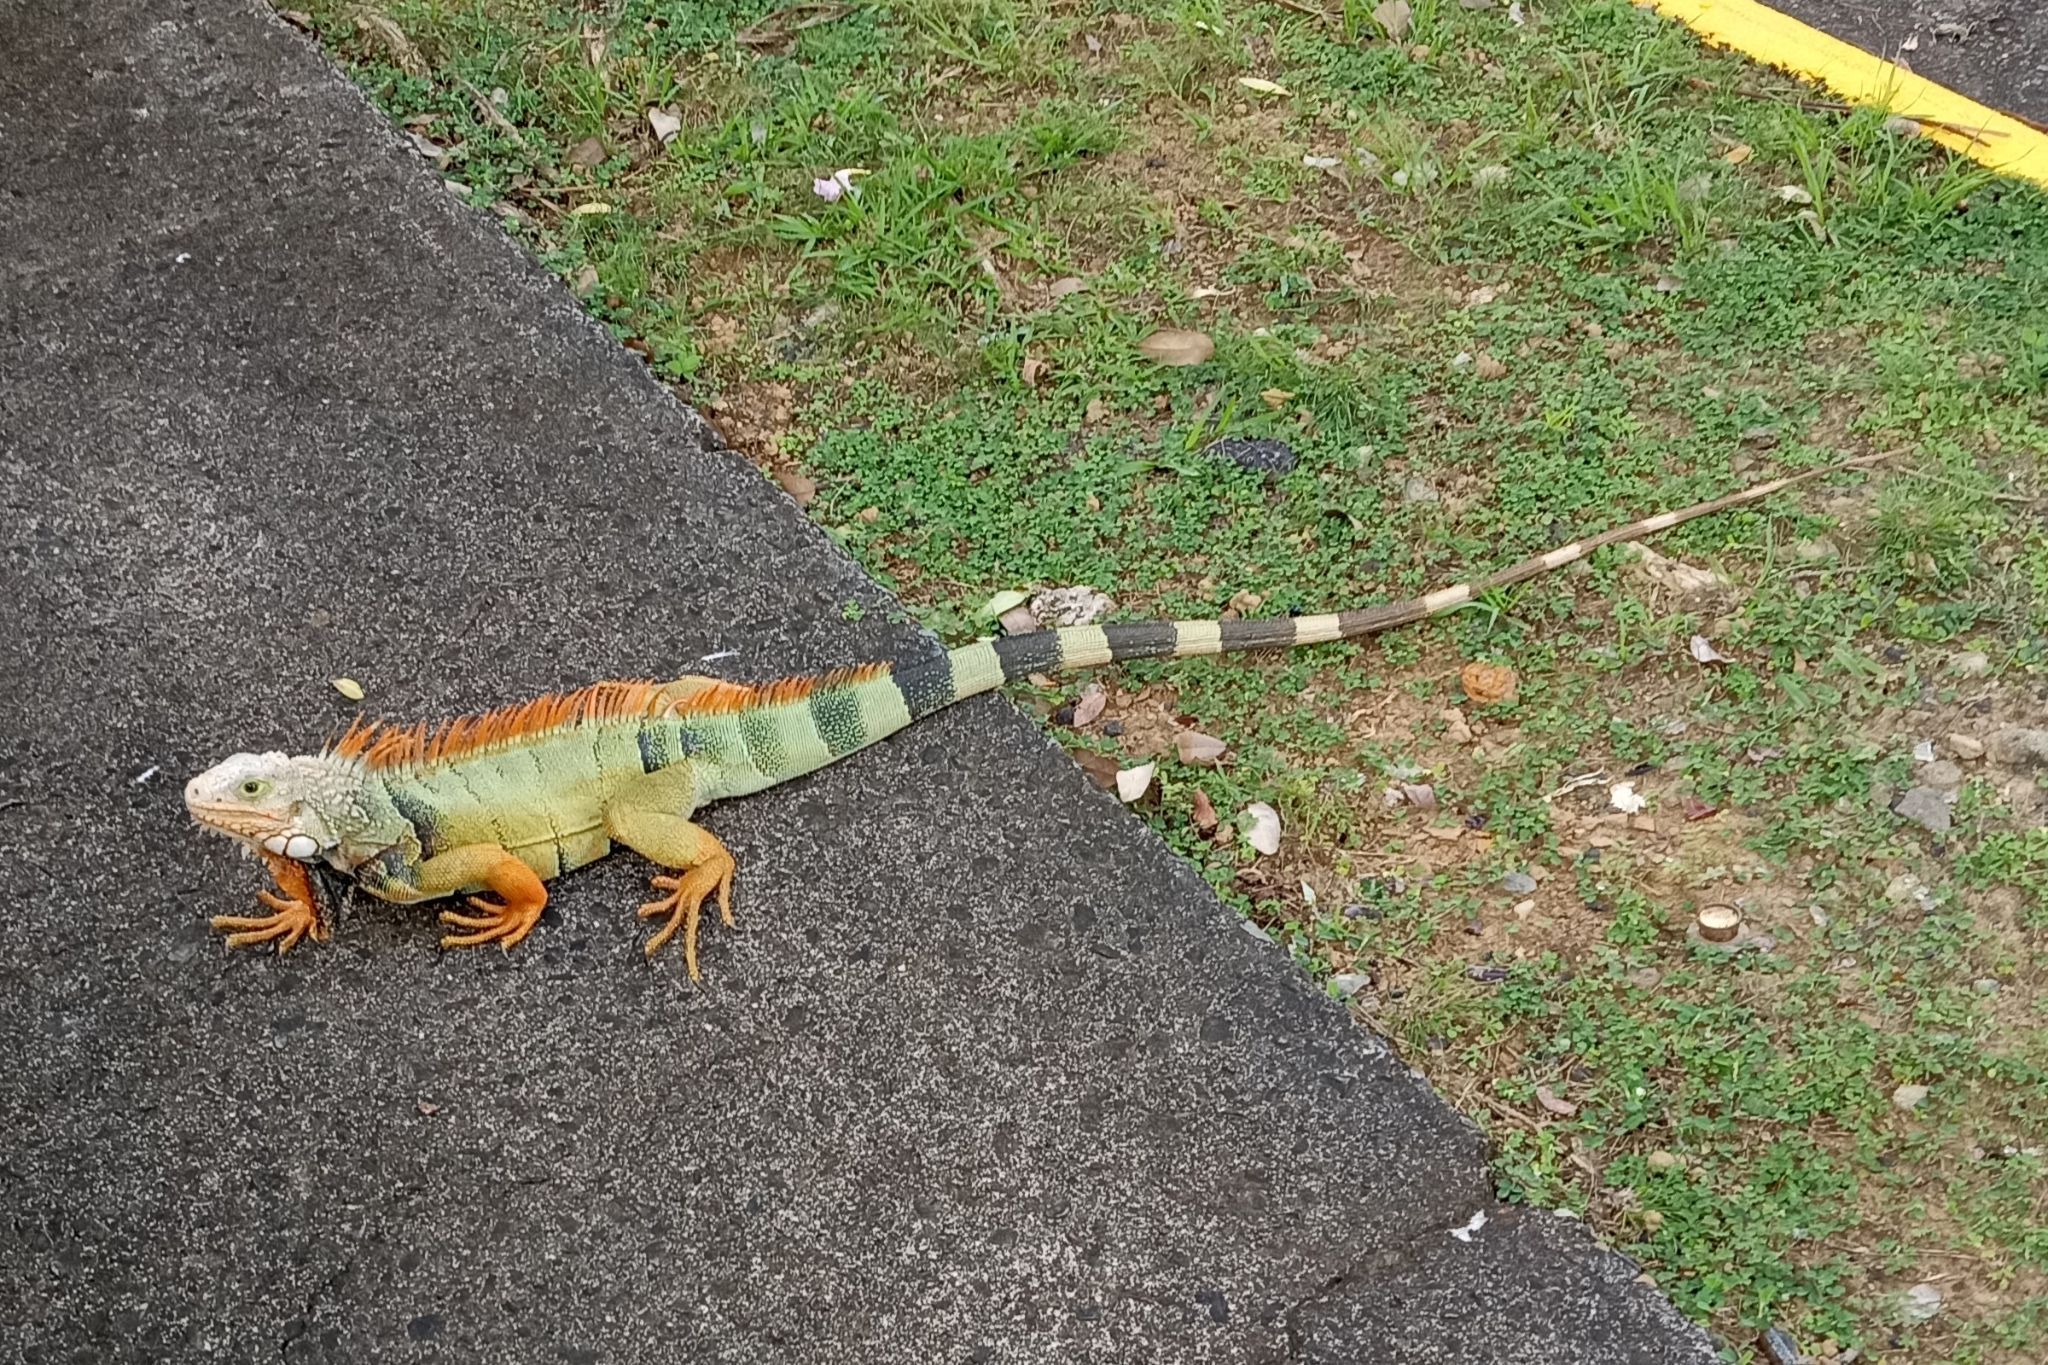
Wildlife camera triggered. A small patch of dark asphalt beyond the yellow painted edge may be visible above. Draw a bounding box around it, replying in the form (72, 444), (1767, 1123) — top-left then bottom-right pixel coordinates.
(1772, 0), (2048, 123)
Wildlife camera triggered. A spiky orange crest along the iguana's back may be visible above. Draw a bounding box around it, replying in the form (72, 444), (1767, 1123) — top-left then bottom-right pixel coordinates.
(328, 663), (889, 772)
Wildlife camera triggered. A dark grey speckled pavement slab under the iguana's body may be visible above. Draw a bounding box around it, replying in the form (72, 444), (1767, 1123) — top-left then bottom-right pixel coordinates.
(0, 0), (1712, 1365)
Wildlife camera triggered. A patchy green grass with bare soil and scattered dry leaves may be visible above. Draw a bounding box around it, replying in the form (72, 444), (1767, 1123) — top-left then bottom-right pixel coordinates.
(296, 0), (2048, 1363)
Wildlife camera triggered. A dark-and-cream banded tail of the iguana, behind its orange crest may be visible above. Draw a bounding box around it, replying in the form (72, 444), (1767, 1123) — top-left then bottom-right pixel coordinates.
(868, 454), (1884, 722)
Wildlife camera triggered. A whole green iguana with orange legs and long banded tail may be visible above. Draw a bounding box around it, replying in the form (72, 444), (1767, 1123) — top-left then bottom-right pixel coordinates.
(184, 458), (1870, 980)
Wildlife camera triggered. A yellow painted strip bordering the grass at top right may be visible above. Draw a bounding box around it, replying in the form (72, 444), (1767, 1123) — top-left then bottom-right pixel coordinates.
(1636, 0), (2048, 188)
